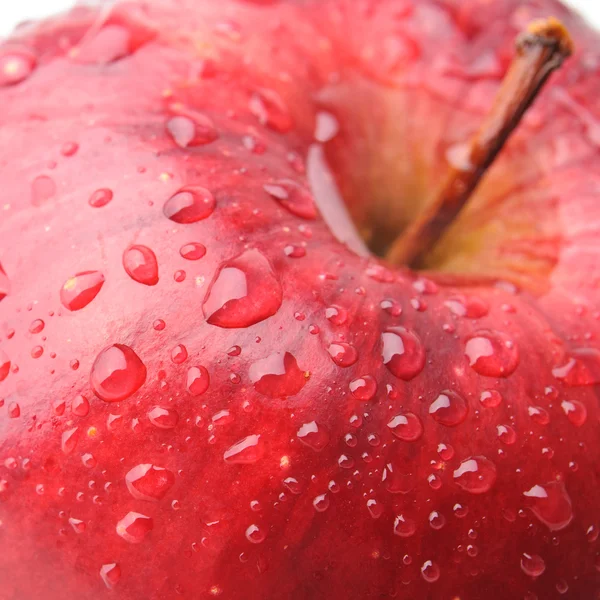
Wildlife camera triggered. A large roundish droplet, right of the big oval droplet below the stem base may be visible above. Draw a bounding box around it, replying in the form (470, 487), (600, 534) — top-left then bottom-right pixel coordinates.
(465, 330), (519, 377)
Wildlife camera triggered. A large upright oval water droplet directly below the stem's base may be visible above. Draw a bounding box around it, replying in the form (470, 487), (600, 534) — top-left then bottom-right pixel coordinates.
(381, 327), (425, 381)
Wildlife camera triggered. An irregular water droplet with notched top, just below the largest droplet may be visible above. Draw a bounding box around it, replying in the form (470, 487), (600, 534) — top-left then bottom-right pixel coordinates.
(249, 352), (307, 398)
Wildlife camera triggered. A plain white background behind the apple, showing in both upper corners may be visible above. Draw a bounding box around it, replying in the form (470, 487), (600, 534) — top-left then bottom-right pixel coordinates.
(0, 0), (600, 36)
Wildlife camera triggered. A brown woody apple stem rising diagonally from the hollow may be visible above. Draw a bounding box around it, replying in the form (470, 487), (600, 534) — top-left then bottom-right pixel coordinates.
(386, 17), (573, 267)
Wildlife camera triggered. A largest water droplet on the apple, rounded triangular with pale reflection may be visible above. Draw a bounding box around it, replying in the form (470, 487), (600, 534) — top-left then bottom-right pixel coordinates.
(202, 250), (283, 328)
